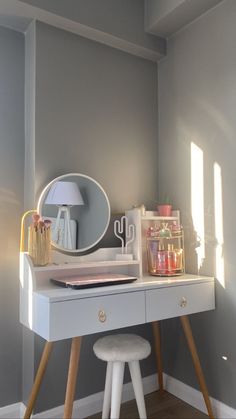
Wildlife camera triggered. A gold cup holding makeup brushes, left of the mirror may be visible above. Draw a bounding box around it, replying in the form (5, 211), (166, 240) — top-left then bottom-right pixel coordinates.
(28, 225), (51, 266)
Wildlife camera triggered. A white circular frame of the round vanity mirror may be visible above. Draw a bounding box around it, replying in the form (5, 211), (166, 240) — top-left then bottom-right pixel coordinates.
(37, 173), (111, 255)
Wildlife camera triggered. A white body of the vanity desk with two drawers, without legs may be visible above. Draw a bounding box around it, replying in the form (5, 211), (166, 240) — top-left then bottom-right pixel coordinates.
(21, 249), (214, 341)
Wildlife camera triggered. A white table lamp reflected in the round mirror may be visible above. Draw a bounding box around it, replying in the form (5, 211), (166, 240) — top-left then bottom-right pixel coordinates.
(45, 181), (84, 249)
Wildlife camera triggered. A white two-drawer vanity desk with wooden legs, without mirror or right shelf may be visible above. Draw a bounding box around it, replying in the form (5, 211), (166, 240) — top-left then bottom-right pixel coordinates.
(20, 248), (215, 418)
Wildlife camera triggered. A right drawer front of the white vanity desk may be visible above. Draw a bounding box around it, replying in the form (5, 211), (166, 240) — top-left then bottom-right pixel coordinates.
(146, 282), (215, 322)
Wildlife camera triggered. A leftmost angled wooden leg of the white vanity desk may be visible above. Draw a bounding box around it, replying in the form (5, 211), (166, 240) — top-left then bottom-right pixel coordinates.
(24, 342), (53, 419)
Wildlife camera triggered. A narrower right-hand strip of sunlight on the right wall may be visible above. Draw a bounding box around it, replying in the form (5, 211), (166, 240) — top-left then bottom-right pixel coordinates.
(214, 162), (225, 288)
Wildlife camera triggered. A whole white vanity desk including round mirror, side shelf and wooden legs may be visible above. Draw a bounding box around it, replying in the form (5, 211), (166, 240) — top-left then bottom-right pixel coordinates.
(20, 173), (215, 419)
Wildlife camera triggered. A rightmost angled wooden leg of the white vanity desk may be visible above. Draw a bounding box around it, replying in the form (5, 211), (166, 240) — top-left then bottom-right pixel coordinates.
(180, 316), (214, 419)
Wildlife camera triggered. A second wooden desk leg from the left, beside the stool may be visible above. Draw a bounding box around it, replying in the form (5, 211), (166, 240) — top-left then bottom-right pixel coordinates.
(63, 336), (82, 419)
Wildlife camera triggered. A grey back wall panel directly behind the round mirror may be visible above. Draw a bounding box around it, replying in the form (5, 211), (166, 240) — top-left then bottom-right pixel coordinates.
(31, 23), (157, 410)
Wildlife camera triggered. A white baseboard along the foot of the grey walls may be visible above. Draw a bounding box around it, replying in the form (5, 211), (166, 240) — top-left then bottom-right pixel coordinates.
(0, 374), (236, 419)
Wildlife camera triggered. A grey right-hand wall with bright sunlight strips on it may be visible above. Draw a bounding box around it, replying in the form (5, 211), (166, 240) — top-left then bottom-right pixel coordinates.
(159, 0), (236, 408)
